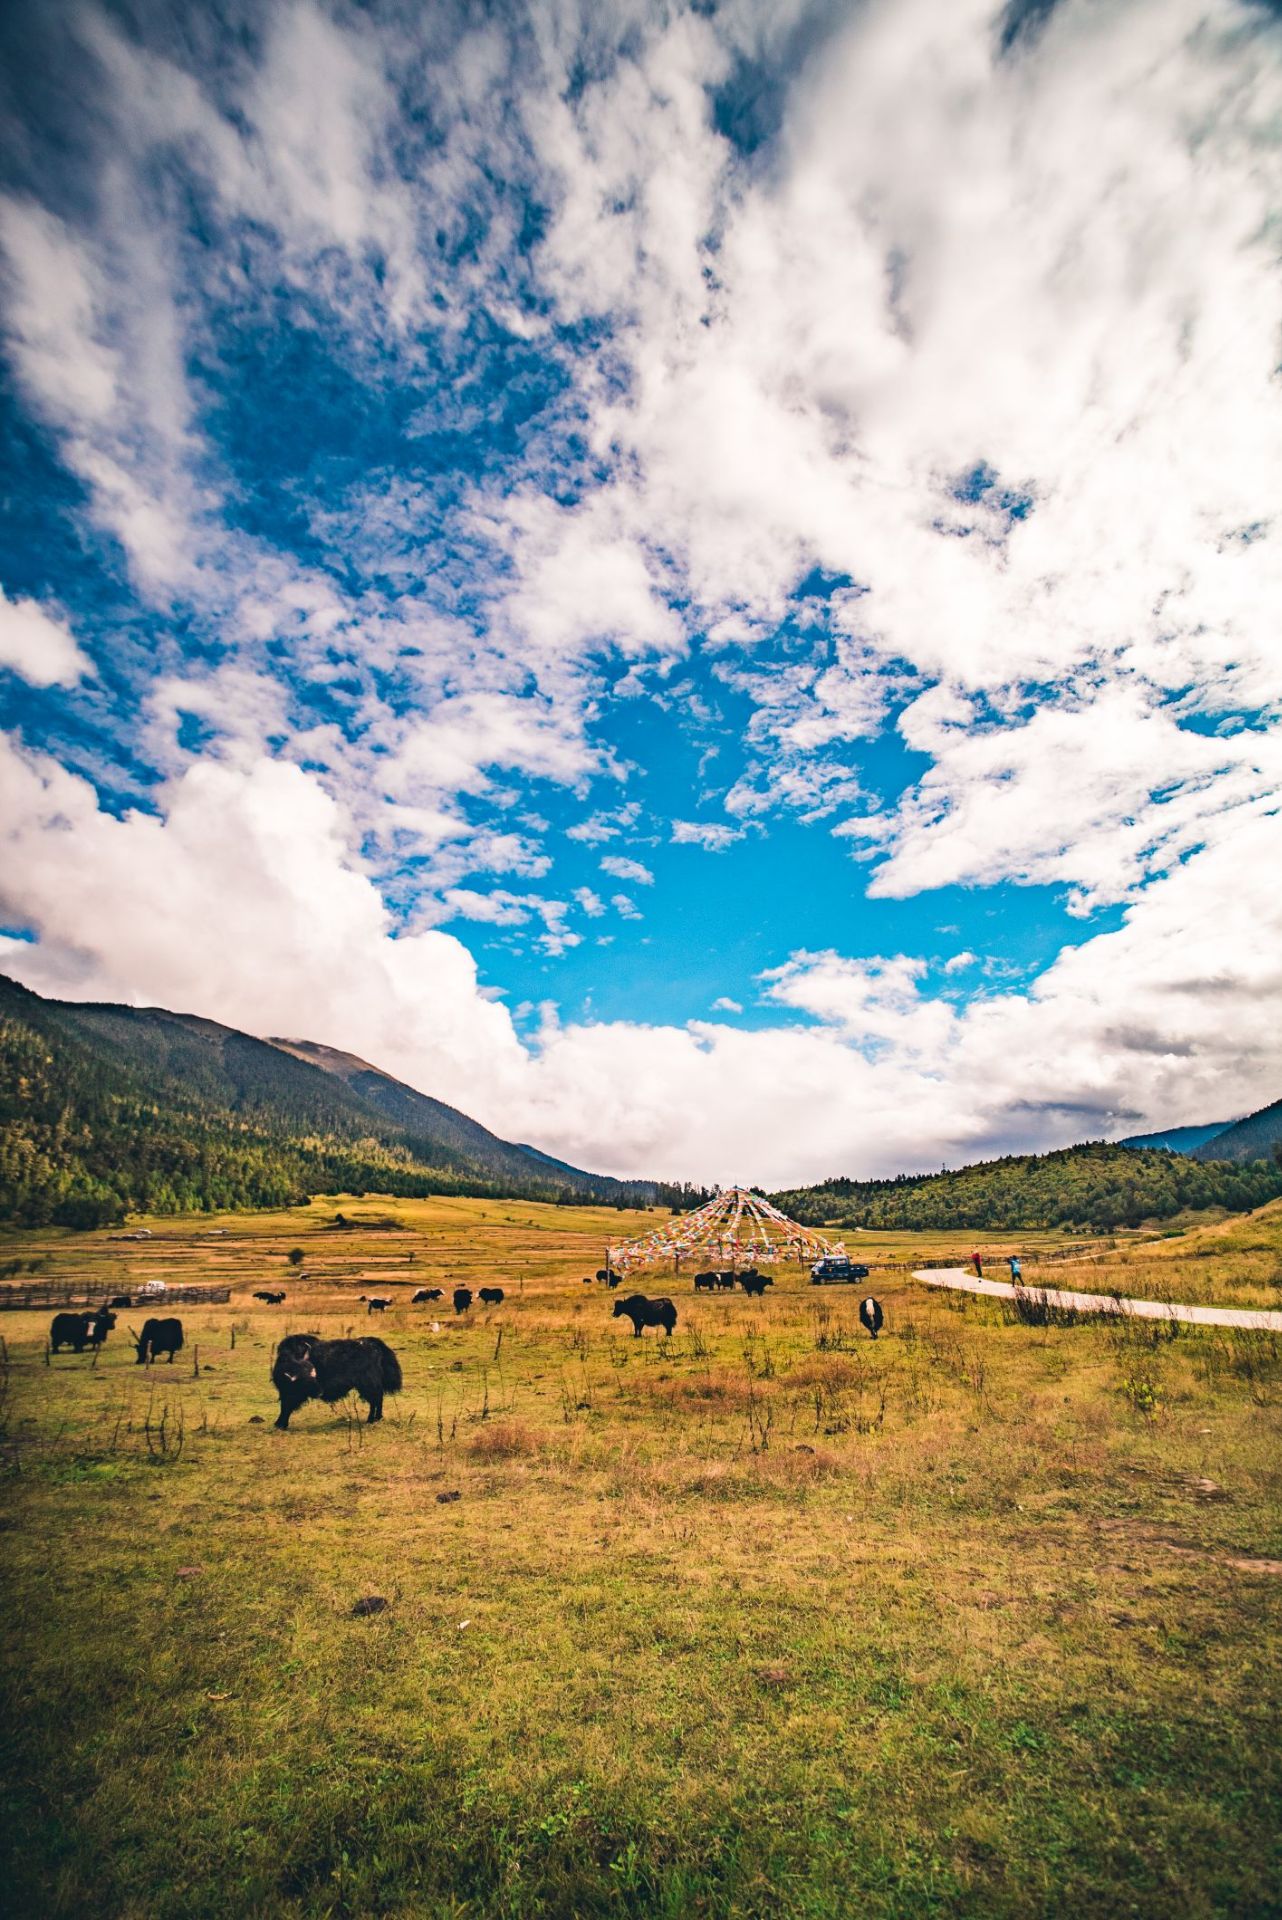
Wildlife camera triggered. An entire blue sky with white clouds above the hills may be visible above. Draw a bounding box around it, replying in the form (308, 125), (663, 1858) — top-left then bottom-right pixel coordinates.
(0, 0), (1282, 1187)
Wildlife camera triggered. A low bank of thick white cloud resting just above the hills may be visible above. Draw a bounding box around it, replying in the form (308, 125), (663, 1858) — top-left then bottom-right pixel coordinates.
(0, 747), (1282, 1183)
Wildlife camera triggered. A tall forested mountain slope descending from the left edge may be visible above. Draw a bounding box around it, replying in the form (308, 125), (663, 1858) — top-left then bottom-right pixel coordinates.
(0, 975), (683, 1227)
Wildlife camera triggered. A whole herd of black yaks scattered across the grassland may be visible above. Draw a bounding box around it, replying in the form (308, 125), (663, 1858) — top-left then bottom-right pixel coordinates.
(40, 1267), (885, 1432)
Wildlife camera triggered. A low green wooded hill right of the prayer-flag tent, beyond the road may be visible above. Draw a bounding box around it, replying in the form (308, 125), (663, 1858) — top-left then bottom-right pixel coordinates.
(772, 1142), (1282, 1233)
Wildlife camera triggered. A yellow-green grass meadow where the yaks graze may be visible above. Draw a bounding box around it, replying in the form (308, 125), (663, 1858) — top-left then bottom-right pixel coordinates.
(0, 1200), (1282, 1920)
